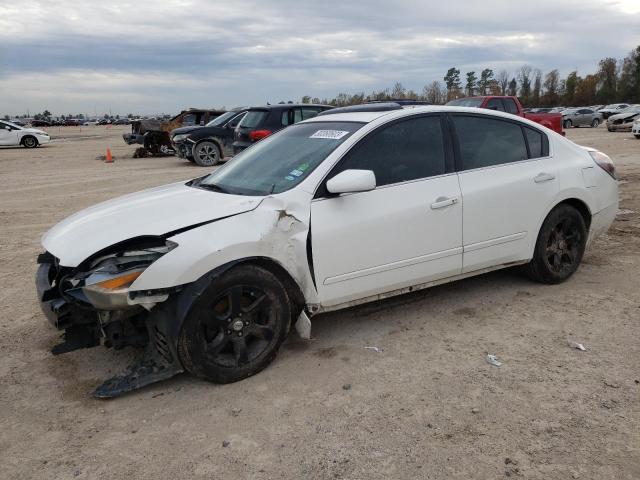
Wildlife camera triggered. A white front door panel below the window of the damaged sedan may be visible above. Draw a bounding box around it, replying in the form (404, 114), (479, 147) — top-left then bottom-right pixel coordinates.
(311, 174), (462, 306)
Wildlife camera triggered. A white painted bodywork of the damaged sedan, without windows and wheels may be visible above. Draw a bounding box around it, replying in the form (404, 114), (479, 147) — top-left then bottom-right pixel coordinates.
(43, 107), (618, 312)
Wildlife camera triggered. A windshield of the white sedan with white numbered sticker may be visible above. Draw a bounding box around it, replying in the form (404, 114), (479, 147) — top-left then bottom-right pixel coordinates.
(194, 122), (364, 196)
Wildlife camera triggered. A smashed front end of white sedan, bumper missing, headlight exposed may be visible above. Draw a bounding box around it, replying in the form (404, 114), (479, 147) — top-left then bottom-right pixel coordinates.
(36, 238), (182, 398)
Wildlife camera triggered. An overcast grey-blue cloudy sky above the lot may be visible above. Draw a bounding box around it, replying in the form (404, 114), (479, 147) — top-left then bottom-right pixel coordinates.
(0, 0), (640, 115)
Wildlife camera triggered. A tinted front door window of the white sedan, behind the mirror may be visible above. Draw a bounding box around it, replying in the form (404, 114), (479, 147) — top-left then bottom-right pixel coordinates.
(329, 116), (446, 186)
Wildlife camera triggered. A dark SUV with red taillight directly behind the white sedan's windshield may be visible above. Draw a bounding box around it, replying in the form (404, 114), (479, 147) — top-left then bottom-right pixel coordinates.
(233, 103), (333, 153)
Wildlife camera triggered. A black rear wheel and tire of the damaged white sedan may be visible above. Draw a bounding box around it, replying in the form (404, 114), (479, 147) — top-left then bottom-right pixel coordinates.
(524, 204), (587, 284)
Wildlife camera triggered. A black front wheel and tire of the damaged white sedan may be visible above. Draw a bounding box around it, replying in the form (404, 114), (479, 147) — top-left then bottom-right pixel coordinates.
(178, 266), (292, 383)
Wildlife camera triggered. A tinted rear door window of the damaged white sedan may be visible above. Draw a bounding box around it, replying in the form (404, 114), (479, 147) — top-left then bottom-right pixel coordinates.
(453, 115), (528, 170)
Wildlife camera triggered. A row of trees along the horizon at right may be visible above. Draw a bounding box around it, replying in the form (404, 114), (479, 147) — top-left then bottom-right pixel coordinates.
(302, 46), (640, 107)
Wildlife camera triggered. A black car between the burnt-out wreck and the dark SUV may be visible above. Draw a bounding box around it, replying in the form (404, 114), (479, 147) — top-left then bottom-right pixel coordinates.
(171, 107), (247, 167)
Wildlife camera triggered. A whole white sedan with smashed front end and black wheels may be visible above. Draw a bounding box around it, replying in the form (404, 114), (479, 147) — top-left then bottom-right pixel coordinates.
(36, 104), (618, 397)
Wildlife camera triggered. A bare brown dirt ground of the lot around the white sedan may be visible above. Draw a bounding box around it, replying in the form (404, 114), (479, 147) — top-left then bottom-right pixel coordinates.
(0, 127), (640, 480)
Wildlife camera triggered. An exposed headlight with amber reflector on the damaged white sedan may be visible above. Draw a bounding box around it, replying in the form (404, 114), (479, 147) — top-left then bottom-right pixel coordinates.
(63, 240), (178, 310)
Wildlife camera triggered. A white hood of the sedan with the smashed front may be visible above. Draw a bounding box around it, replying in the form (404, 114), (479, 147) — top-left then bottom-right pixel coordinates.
(42, 182), (262, 267)
